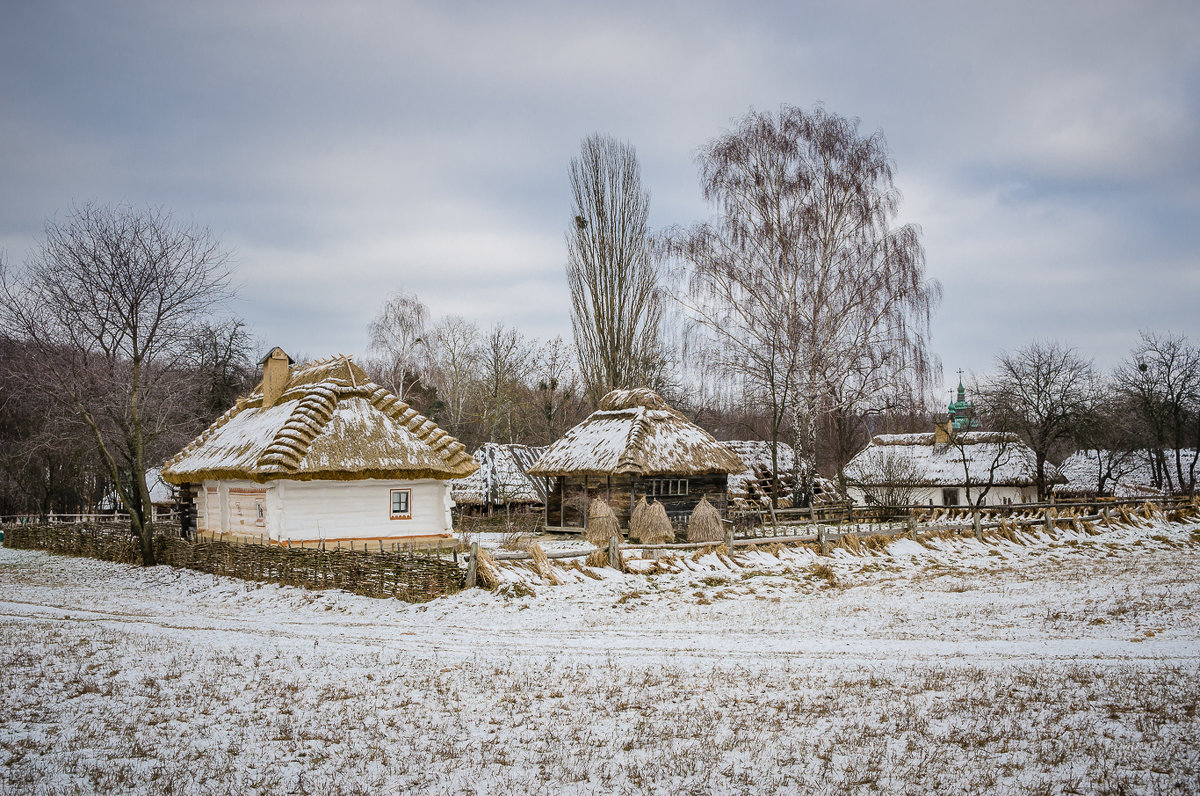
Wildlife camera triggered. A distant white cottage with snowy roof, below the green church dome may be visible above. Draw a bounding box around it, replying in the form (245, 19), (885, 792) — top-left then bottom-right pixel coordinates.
(846, 427), (1066, 505)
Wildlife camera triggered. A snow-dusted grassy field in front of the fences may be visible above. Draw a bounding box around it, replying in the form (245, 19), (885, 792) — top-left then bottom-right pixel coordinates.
(0, 525), (1200, 794)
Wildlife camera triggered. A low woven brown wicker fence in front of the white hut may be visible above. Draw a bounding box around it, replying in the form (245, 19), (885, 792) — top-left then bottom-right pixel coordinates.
(4, 523), (467, 603)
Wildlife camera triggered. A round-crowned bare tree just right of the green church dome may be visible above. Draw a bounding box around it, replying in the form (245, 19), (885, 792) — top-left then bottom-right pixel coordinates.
(980, 341), (1099, 499)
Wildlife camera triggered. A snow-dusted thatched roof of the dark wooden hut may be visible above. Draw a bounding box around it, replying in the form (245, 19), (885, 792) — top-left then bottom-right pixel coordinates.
(529, 389), (742, 475)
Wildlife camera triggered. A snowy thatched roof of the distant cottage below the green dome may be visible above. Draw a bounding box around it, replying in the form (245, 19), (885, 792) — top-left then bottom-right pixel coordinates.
(846, 431), (1063, 486)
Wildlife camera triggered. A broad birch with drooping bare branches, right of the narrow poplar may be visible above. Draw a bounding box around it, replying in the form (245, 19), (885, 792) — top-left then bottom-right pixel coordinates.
(667, 106), (941, 502)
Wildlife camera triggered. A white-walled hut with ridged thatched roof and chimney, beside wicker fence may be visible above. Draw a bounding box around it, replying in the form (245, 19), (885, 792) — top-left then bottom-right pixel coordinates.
(162, 348), (478, 544)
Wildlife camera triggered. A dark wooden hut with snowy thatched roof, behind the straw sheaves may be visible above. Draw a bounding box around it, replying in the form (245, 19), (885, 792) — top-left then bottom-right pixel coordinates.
(528, 389), (743, 531)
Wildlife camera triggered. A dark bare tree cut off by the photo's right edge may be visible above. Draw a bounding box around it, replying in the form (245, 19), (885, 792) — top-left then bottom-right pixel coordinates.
(1116, 333), (1200, 495)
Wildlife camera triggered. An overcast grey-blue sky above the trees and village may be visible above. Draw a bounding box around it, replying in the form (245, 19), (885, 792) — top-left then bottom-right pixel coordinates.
(0, 0), (1200, 398)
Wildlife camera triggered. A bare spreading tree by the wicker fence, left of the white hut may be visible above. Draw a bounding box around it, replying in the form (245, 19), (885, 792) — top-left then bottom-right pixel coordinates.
(0, 204), (229, 565)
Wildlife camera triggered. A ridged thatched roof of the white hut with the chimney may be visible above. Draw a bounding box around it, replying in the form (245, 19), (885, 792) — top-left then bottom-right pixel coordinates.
(162, 357), (478, 484)
